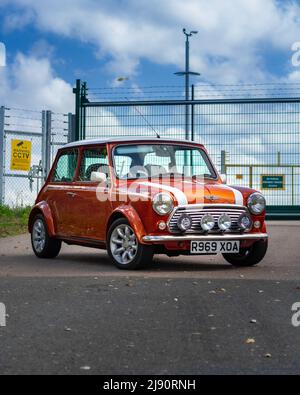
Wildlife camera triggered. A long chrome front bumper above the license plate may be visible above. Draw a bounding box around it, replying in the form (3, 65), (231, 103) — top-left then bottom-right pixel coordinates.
(143, 233), (268, 243)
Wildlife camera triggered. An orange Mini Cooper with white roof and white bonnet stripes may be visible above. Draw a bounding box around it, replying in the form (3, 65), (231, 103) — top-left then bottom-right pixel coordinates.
(29, 137), (268, 269)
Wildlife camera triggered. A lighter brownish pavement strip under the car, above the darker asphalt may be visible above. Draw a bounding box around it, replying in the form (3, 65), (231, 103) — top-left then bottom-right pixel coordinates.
(0, 221), (300, 280)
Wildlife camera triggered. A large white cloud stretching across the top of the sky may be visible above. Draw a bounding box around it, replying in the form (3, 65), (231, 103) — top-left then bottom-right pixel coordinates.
(0, 0), (300, 82)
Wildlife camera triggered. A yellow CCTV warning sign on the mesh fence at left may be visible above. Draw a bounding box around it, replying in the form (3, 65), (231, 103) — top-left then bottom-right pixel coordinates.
(10, 140), (31, 171)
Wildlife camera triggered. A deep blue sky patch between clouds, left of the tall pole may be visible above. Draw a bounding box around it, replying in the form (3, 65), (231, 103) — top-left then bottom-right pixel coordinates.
(1, 19), (185, 87)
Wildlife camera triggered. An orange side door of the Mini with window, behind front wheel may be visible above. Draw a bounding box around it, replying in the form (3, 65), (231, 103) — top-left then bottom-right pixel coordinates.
(70, 145), (111, 241)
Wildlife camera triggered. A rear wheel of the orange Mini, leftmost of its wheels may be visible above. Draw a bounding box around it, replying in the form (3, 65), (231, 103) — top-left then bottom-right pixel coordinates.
(31, 214), (61, 259)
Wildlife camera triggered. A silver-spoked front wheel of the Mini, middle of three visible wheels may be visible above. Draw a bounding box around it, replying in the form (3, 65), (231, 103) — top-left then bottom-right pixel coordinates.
(107, 218), (153, 270)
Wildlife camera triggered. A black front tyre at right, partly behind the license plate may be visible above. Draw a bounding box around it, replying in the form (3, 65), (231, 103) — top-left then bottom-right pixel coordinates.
(223, 240), (268, 267)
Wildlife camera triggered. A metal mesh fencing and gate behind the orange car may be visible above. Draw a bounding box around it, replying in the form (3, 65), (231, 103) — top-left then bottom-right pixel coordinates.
(0, 81), (300, 218)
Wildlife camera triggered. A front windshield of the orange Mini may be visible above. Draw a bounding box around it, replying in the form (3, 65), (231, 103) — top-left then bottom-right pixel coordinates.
(113, 144), (217, 179)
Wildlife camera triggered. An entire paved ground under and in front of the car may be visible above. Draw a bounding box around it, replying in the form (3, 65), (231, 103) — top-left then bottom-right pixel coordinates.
(0, 222), (300, 375)
